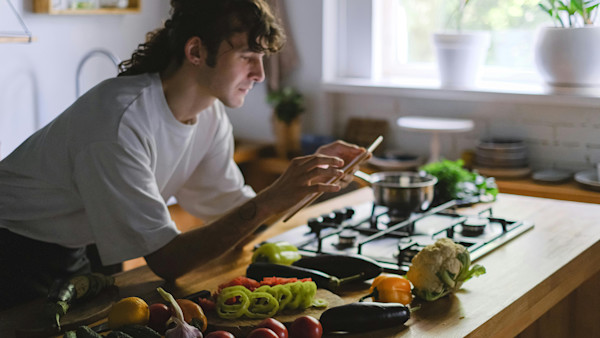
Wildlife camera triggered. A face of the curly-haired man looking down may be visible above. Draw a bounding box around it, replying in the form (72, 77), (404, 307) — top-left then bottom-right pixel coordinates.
(204, 33), (265, 108)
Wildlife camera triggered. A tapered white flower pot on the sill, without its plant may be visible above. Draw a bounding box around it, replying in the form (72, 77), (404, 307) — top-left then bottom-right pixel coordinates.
(433, 32), (490, 88)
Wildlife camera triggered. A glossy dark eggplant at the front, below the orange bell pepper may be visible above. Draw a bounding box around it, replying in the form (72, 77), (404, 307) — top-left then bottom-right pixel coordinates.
(320, 302), (410, 333)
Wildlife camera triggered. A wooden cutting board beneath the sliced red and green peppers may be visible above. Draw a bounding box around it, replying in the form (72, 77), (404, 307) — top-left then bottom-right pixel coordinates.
(206, 289), (345, 337)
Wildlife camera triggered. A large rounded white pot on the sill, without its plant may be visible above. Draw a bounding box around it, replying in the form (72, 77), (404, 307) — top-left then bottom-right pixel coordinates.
(534, 26), (600, 87)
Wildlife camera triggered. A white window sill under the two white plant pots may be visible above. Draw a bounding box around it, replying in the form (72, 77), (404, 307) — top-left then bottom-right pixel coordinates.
(322, 78), (600, 107)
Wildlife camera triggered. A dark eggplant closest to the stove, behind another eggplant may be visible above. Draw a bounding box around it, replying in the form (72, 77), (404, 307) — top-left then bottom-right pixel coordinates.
(292, 254), (383, 281)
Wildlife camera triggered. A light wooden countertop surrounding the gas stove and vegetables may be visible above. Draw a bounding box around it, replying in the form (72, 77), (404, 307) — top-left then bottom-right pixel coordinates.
(0, 188), (600, 337)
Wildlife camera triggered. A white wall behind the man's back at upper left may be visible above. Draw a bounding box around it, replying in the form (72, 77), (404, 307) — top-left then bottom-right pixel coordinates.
(0, 0), (169, 157)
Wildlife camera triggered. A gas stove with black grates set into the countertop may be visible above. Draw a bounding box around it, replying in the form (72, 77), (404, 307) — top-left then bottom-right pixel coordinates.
(269, 201), (533, 274)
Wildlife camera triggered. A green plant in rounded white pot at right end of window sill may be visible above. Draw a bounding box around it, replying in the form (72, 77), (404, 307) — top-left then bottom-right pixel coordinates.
(534, 0), (600, 87)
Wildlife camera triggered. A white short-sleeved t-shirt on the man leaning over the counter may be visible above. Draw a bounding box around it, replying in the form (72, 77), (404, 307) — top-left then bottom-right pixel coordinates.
(0, 74), (255, 265)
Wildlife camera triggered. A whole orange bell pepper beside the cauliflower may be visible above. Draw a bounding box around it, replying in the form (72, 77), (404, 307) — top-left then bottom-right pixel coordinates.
(360, 275), (413, 305)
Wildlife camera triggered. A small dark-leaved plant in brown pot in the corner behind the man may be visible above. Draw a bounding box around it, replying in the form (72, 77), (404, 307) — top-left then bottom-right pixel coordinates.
(267, 87), (305, 158)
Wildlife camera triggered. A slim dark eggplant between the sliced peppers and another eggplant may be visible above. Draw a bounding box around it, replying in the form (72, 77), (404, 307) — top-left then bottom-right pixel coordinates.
(246, 262), (342, 291)
